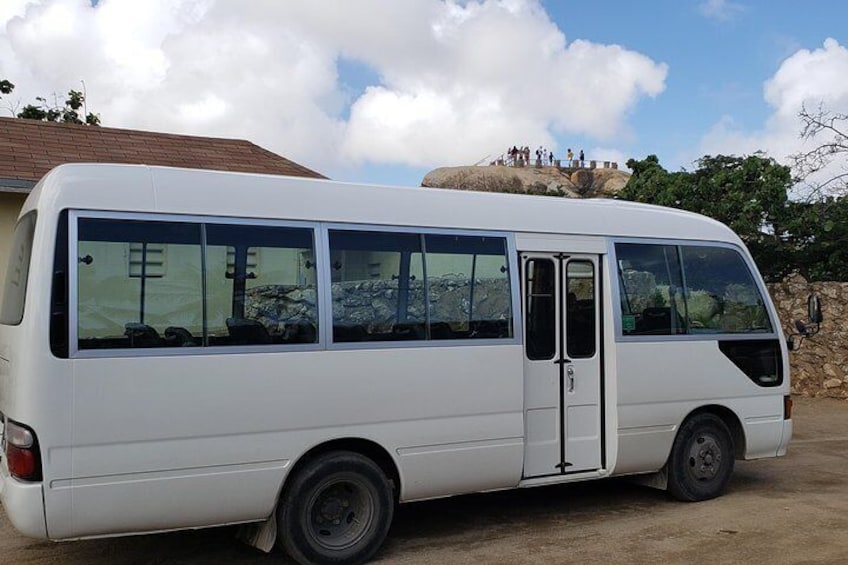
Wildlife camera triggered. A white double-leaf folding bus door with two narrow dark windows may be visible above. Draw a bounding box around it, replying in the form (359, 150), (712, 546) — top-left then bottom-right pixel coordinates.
(521, 253), (603, 478)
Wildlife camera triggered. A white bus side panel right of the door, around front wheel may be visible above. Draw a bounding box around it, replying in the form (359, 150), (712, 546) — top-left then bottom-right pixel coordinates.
(614, 339), (789, 475)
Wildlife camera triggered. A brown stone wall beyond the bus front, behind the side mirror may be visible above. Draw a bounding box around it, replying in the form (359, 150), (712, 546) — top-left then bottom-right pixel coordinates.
(768, 276), (848, 399)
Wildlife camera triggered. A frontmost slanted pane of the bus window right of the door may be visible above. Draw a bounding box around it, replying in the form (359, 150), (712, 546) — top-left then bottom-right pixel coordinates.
(682, 246), (772, 333)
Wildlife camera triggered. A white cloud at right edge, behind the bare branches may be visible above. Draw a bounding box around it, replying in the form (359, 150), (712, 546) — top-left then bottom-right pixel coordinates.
(701, 39), (848, 194)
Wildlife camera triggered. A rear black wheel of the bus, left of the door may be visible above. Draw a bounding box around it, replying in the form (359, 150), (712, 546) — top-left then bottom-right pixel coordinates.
(277, 451), (394, 564)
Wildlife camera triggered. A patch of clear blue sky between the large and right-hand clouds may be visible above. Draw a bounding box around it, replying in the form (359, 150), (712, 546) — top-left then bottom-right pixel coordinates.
(544, 0), (848, 172)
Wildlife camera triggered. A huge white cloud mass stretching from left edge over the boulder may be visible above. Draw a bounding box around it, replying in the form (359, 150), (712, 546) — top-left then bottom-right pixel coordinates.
(0, 0), (667, 176)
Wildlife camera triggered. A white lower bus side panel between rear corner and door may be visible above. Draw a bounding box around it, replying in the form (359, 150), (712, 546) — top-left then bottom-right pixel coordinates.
(48, 345), (523, 538)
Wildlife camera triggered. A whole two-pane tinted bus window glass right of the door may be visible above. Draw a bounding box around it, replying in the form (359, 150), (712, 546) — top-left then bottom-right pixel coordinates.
(616, 243), (772, 335)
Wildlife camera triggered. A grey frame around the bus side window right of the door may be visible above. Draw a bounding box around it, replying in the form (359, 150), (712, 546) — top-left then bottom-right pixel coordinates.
(607, 237), (782, 343)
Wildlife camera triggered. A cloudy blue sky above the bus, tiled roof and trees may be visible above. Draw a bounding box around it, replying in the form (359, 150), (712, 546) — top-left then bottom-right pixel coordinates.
(0, 0), (848, 185)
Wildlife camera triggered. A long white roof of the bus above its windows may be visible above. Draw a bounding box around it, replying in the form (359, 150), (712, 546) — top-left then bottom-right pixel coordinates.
(22, 164), (741, 244)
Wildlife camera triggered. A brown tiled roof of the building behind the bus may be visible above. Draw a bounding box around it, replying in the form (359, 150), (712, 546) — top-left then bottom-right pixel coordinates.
(0, 118), (326, 185)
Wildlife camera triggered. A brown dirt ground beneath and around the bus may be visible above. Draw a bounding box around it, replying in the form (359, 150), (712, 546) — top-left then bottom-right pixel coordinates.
(0, 398), (848, 565)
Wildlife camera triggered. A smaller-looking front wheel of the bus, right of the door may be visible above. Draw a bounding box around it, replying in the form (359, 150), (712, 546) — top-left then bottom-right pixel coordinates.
(666, 414), (735, 502)
